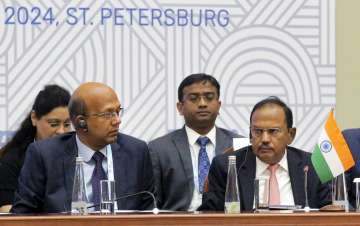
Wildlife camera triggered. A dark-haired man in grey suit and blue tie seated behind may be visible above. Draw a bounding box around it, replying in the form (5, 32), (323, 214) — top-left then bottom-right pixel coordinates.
(149, 74), (239, 211)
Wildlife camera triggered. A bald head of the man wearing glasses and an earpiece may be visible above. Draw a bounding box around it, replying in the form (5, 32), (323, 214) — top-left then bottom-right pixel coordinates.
(69, 82), (121, 150)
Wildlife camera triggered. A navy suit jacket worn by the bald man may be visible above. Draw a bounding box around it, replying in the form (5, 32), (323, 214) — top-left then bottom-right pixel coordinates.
(11, 133), (154, 213)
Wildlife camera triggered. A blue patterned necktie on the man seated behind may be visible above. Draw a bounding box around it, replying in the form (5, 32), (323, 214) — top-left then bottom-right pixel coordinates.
(196, 137), (210, 194)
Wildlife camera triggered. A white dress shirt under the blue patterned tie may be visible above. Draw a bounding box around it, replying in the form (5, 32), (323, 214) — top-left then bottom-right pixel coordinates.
(185, 126), (216, 211)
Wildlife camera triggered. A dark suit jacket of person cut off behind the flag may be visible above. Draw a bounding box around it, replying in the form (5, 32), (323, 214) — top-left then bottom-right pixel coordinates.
(342, 129), (360, 206)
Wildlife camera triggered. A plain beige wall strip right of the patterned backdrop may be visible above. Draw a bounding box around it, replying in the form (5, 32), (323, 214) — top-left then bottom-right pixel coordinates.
(336, 0), (360, 129)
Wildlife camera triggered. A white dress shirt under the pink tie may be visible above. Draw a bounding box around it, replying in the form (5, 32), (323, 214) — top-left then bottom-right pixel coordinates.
(256, 150), (294, 205)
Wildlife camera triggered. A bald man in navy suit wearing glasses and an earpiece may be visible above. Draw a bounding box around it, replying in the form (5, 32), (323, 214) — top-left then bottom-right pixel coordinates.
(11, 83), (154, 213)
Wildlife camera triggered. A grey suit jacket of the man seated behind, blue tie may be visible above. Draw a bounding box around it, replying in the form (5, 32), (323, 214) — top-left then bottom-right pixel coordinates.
(149, 127), (239, 211)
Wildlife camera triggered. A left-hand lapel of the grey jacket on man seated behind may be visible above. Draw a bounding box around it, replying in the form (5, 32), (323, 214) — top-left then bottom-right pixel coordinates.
(173, 127), (194, 197)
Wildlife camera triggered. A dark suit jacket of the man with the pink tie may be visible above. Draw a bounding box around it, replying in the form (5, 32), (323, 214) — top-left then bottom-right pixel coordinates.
(199, 146), (331, 211)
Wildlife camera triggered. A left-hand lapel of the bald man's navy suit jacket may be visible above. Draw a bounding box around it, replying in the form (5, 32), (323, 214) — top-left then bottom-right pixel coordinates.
(63, 133), (78, 209)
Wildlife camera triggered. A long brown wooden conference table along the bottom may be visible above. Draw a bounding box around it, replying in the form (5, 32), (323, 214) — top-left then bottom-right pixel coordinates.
(0, 211), (360, 226)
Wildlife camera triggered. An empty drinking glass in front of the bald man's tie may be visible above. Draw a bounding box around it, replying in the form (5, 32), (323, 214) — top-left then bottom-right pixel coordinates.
(100, 180), (115, 214)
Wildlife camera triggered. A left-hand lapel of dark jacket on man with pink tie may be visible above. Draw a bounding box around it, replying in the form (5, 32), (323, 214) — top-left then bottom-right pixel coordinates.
(236, 148), (256, 210)
